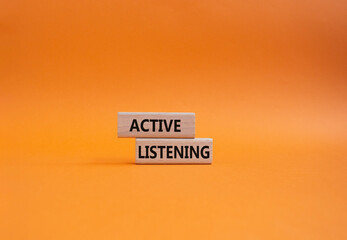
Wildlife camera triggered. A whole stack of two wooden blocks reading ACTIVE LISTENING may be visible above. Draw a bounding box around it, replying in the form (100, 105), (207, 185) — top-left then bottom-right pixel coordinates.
(118, 112), (213, 164)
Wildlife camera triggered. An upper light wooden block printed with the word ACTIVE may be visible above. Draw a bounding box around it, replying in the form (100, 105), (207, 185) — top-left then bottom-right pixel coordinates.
(118, 112), (195, 138)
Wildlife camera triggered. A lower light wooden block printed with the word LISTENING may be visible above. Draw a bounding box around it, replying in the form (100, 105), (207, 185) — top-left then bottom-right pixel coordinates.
(136, 138), (213, 164)
